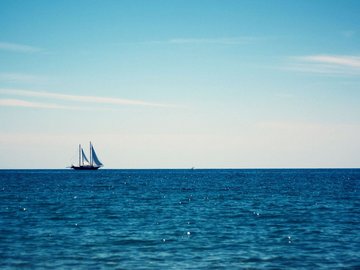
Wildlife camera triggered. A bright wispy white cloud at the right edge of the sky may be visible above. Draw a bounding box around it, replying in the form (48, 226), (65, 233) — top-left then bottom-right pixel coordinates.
(286, 55), (360, 76)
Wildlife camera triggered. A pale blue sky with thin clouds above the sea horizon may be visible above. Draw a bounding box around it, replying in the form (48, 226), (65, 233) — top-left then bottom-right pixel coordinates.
(0, 0), (360, 169)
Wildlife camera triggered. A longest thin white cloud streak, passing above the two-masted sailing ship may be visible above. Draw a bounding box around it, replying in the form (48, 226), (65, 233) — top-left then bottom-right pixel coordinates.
(0, 89), (175, 109)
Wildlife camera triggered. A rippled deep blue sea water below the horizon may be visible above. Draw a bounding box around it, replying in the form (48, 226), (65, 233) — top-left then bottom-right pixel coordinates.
(0, 169), (360, 269)
